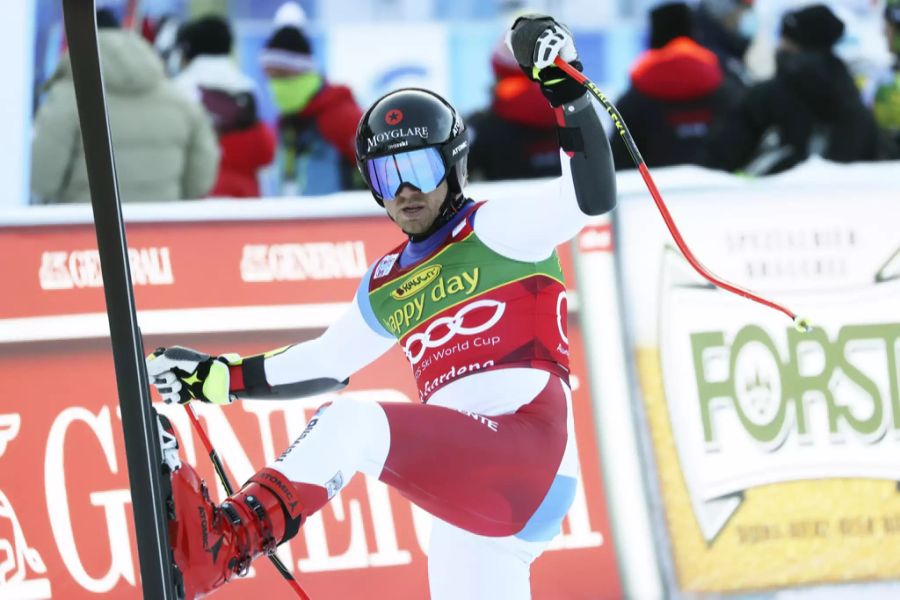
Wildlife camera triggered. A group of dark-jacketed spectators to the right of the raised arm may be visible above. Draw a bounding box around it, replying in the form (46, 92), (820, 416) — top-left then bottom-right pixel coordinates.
(612, 0), (900, 176)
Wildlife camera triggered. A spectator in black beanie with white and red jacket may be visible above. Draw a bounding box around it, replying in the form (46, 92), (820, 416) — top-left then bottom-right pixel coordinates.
(175, 15), (275, 198)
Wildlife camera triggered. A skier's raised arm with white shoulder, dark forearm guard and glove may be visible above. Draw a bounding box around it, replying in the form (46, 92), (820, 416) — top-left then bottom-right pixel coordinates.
(475, 15), (616, 260)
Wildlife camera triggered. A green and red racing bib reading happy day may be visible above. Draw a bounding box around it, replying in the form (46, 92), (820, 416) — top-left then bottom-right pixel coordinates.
(369, 205), (569, 402)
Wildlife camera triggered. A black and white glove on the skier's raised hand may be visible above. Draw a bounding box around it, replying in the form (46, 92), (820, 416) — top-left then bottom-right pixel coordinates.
(507, 15), (587, 107)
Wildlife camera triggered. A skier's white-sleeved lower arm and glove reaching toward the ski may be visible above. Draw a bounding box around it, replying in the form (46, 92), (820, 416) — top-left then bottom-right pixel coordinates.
(147, 276), (395, 404)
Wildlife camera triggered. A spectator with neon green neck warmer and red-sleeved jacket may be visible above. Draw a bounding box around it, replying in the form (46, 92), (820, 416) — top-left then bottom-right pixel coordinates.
(261, 2), (362, 196)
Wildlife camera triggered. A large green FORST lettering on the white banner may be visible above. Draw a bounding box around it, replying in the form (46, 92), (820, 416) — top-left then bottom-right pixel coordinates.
(691, 323), (900, 452)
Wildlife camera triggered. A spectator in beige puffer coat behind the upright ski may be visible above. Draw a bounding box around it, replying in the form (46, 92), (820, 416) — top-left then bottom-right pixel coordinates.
(31, 10), (219, 203)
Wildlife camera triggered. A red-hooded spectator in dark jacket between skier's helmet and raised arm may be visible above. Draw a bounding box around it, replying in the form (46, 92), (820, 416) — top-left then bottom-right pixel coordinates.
(466, 40), (560, 181)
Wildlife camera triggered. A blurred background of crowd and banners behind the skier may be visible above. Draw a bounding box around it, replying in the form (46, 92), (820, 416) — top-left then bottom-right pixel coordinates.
(0, 0), (900, 600)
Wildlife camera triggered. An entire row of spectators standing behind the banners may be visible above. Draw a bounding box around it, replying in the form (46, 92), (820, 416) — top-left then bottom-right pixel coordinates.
(31, 0), (900, 203)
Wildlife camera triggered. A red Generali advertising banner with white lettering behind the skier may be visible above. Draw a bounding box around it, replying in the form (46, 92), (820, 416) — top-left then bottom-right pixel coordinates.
(0, 203), (620, 600)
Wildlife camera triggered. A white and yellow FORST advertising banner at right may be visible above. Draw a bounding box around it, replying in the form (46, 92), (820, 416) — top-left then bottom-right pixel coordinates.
(616, 163), (900, 592)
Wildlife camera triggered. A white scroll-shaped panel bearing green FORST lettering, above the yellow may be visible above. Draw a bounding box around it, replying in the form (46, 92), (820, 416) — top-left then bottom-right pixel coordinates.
(660, 251), (900, 540)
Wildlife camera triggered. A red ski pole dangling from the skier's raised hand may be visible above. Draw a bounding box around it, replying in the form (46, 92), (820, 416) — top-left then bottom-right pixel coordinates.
(553, 56), (811, 331)
